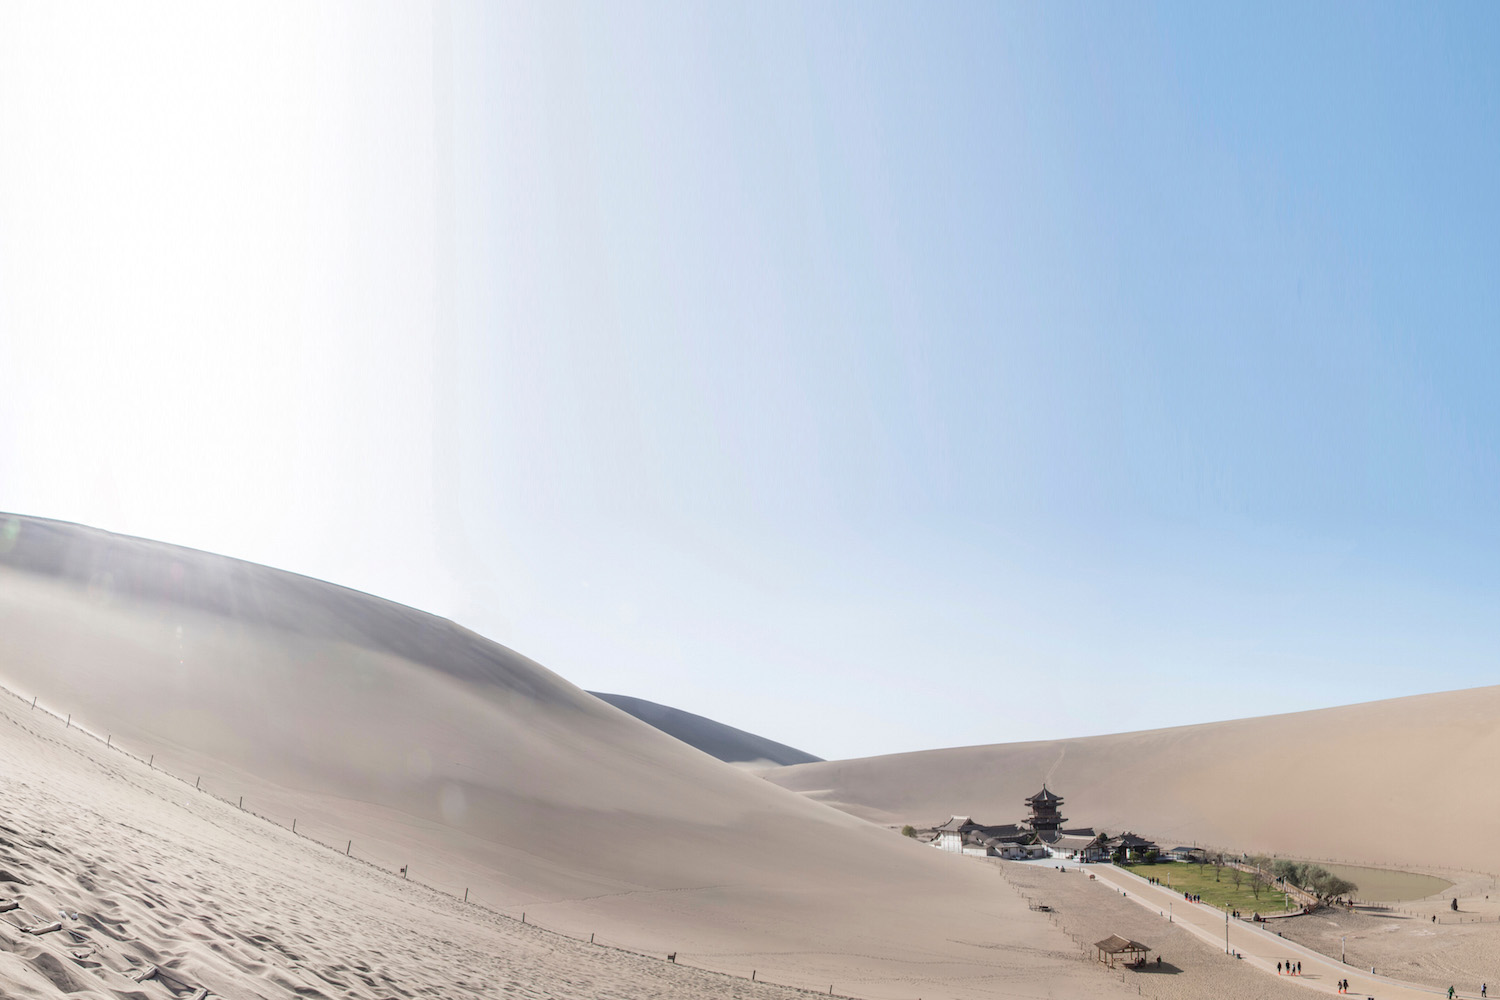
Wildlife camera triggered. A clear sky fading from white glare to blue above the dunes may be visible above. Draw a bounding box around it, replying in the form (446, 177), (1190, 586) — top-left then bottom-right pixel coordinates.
(0, 1), (1500, 759)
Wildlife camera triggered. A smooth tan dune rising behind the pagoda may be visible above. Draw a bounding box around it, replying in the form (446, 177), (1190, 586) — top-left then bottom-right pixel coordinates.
(765, 687), (1500, 868)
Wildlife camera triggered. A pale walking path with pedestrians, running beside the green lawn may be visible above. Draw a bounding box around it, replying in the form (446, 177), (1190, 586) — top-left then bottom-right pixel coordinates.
(1082, 865), (1479, 1000)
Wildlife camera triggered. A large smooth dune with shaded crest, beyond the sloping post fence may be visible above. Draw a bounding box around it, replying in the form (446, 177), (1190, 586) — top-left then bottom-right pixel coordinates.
(0, 520), (1118, 997)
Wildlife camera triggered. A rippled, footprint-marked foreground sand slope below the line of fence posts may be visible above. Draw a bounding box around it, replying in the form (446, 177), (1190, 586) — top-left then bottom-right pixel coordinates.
(0, 696), (888, 1000)
